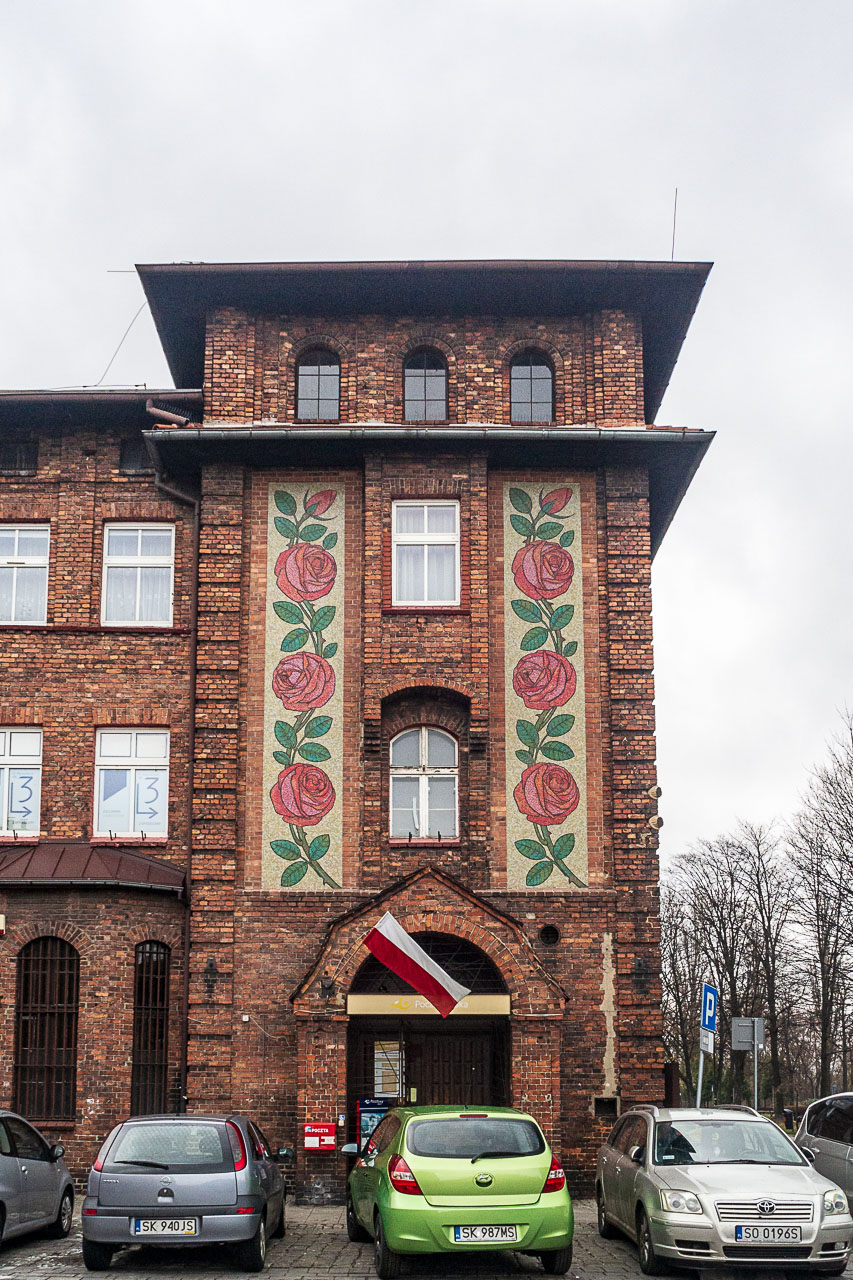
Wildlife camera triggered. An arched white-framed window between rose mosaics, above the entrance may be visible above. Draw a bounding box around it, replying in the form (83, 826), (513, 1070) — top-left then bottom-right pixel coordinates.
(391, 726), (459, 840)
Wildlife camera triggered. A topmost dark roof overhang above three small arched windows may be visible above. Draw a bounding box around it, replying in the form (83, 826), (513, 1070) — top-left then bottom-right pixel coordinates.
(137, 260), (711, 422)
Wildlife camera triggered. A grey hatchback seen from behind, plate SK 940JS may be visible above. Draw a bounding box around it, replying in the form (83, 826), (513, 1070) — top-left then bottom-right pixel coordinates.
(83, 1115), (284, 1271)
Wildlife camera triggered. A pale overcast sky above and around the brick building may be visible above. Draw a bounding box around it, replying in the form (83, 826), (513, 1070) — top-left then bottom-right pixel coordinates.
(0, 0), (853, 855)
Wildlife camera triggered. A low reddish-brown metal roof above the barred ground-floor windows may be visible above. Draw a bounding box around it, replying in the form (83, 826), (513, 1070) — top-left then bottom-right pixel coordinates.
(0, 840), (186, 899)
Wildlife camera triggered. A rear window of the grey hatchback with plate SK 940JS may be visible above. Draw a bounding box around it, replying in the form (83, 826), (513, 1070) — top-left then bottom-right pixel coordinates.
(108, 1120), (234, 1174)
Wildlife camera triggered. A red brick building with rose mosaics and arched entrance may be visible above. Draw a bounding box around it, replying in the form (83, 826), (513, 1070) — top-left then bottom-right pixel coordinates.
(0, 262), (711, 1199)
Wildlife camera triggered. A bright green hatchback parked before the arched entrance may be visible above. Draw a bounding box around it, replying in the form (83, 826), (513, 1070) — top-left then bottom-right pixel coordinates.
(343, 1106), (574, 1280)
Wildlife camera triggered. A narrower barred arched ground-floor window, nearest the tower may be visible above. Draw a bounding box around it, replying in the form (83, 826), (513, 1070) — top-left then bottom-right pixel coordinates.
(131, 942), (172, 1116)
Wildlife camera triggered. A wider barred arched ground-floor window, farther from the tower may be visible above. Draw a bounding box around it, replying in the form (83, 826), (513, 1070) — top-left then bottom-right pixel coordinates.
(14, 937), (79, 1120)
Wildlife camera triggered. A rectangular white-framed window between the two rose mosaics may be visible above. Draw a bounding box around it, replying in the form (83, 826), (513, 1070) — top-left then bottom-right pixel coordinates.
(391, 502), (460, 605)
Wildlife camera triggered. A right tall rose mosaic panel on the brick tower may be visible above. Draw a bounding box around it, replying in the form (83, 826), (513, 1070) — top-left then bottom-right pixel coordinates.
(503, 483), (588, 892)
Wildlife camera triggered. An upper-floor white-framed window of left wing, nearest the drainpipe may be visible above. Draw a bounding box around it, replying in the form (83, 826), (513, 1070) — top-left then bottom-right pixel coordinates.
(101, 525), (174, 627)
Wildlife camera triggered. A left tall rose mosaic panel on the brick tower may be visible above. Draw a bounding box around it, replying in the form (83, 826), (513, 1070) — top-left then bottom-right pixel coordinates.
(263, 484), (345, 891)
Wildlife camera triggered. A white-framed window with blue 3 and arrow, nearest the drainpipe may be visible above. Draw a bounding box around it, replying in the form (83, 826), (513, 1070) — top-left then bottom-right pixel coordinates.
(93, 728), (169, 838)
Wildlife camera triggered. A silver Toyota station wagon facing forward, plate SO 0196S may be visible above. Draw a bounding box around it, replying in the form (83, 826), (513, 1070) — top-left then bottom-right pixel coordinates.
(596, 1106), (853, 1276)
